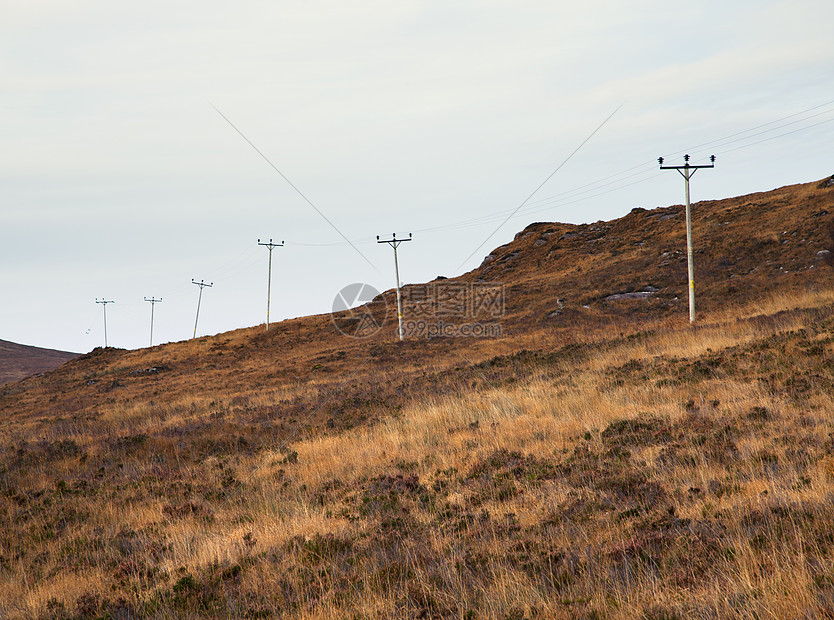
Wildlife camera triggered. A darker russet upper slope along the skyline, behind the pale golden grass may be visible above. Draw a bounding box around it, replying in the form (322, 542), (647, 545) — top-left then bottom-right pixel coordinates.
(0, 177), (834, 423)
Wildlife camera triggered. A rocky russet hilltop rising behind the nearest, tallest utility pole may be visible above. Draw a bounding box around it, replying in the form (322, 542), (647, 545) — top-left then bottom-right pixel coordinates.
(467, 180), (834, 322)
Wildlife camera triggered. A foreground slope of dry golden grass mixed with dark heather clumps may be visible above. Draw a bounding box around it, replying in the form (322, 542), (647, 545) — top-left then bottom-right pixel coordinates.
(0, 284), (834, 619)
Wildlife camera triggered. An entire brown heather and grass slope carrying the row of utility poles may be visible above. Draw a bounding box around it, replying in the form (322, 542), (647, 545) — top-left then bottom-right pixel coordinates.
(0, 177), (834, 620)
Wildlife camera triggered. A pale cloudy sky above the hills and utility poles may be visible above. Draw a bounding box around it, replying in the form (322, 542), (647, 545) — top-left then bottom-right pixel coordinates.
(0, 0), (834, 353)
